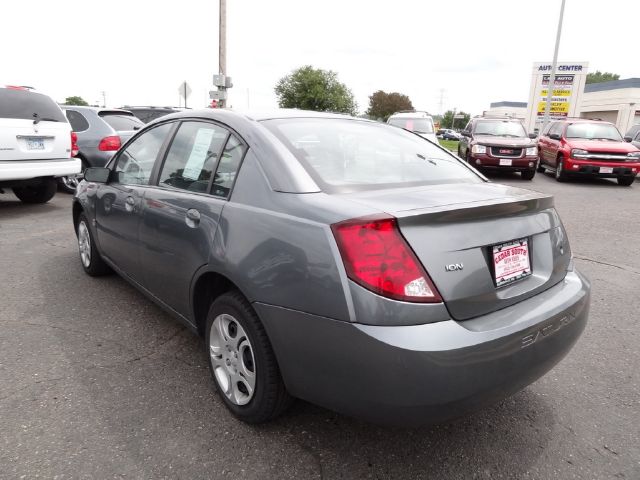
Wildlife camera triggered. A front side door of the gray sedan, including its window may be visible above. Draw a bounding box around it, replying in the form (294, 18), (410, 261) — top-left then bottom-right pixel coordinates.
(95, 123), (173, 283)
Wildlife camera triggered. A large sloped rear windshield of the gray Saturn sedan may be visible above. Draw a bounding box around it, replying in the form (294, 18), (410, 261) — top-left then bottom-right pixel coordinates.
(263, 118), (482, 193)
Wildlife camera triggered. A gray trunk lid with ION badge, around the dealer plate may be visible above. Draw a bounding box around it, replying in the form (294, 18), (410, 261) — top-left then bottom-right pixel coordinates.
(344, 183), (571, 320)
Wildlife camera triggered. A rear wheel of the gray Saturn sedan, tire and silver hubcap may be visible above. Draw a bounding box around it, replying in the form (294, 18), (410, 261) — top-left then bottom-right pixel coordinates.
(205, 291), (292, 423)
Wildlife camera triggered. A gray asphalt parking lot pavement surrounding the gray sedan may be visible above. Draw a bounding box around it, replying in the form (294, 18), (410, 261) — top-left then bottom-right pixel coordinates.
(0, 174), (640, 479)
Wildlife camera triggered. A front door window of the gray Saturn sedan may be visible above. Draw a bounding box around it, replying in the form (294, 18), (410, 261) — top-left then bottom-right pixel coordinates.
(115, 123), (173, 185)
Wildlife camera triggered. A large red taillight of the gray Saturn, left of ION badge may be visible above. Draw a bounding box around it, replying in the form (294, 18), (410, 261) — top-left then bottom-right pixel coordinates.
(331, 216), (442, 303)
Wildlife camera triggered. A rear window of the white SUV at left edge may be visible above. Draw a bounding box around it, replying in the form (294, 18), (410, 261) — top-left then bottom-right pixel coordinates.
(0, 88), (67, 123)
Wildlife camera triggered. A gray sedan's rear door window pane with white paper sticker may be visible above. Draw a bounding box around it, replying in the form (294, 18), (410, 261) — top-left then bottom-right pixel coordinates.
(158, 122), (229, 192)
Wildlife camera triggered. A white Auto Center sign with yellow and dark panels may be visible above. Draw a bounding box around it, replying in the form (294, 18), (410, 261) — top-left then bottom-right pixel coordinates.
(526, 62), (589, 131)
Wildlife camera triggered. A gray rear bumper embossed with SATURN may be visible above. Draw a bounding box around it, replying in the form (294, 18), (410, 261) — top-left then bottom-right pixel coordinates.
(255, 271), (590, 426)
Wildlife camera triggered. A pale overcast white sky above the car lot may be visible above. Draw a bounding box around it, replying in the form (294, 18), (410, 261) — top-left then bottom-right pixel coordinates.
(0, 0), (640, 114)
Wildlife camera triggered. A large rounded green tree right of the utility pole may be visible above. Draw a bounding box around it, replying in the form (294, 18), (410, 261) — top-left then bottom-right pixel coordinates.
(275, 65), (358, 115)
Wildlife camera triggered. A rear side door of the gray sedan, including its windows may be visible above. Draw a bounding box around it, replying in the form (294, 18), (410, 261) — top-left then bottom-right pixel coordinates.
(140, 120), (246, 318)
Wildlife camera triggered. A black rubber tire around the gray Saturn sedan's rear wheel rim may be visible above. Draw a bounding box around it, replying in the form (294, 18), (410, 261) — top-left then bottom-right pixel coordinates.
(204, 291), (293, 423)
